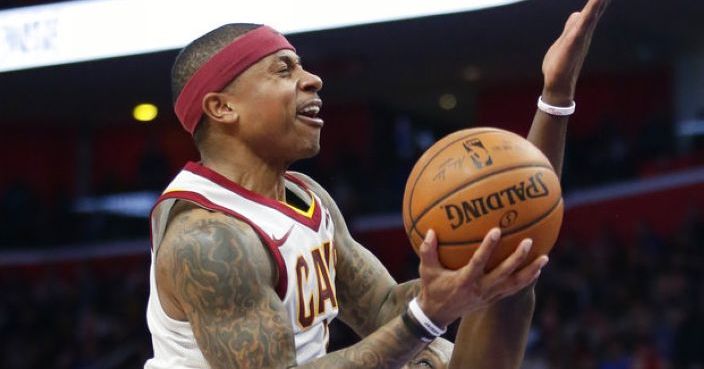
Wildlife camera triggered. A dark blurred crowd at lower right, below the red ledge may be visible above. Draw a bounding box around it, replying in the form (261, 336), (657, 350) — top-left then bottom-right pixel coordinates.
(525, 210), (704, 369)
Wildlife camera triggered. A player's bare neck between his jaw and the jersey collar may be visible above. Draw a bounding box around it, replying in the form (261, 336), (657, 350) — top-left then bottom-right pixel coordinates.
(202, 151), (286, 200)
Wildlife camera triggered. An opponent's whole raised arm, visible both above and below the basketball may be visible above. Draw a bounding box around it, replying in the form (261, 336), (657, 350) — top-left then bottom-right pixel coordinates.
(450, 0), (610, 369)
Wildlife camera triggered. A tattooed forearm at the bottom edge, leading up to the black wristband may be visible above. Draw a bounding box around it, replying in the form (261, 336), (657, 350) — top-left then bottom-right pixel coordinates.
(296, 317), (427, 369)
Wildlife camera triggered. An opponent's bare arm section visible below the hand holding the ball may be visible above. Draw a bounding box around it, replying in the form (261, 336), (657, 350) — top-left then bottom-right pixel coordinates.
(449, 286), (535, 369)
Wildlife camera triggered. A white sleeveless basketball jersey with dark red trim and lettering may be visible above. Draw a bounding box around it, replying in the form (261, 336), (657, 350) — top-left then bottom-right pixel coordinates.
(144, 162), (338, 369)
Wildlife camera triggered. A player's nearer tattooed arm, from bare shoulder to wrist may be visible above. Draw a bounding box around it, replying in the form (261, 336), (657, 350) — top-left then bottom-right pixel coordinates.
(157, 204), (424, 369)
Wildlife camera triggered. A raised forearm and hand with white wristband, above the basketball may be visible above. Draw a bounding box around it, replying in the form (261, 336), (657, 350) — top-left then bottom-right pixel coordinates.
(528, 0), (610, 176)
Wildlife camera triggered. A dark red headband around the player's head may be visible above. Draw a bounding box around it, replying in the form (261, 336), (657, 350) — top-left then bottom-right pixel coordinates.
(175, 26), (296, 135)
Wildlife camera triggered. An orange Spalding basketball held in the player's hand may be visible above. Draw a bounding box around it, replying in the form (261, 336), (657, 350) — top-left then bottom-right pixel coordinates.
(403, 128), (563, 269)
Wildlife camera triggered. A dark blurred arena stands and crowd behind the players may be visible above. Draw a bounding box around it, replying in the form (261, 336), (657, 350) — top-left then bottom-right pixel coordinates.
(0, 0), (704, 369)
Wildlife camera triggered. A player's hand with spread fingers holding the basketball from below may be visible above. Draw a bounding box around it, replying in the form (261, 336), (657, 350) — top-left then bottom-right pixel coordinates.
(418, 228), (548, 326)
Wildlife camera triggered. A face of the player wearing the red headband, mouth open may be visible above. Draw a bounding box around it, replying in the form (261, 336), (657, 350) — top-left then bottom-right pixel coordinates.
(225, 50), (323, 163)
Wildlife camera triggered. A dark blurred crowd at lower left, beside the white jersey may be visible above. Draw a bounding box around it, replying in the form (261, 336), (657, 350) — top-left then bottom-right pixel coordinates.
(0, 257), (151, 369)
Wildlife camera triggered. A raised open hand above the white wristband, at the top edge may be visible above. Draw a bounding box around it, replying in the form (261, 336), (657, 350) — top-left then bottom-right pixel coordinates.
(543, 0), (611, 106)
